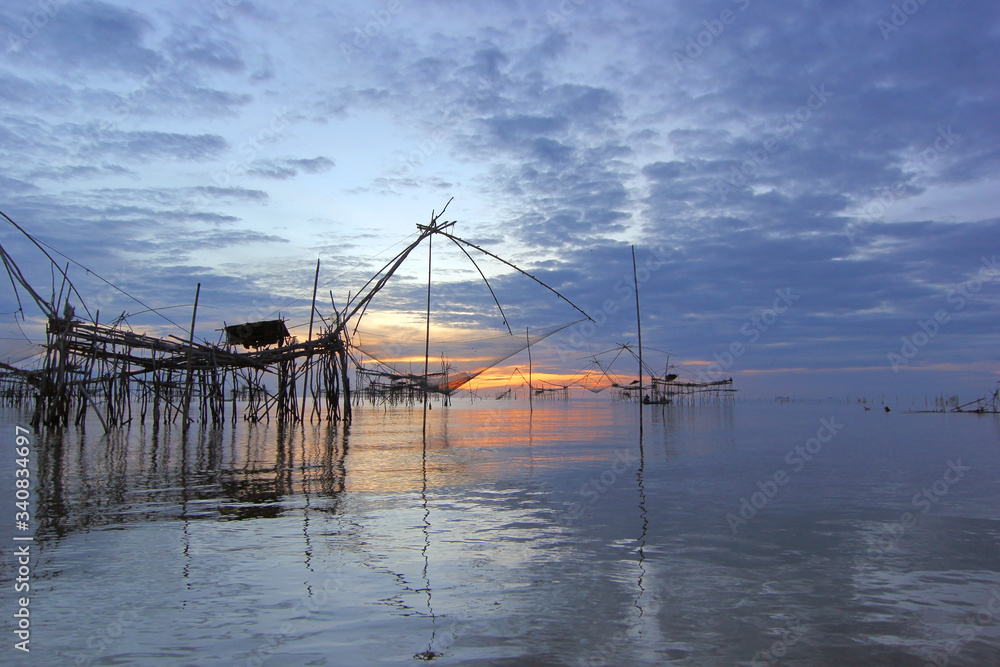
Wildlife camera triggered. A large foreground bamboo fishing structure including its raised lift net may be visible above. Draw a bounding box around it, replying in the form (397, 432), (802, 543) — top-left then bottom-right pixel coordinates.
(0, 200), (590, 431)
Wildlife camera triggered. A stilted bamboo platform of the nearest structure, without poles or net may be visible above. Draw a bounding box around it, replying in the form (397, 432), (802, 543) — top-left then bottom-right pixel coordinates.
(17, 306), (350, 430)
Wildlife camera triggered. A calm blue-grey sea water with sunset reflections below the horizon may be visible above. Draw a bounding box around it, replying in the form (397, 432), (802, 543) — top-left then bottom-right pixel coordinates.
(0, 401), (1000, 666)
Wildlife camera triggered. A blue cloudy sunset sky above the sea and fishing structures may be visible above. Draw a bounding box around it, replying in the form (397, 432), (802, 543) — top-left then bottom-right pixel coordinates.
(0, 0), (1000, 402)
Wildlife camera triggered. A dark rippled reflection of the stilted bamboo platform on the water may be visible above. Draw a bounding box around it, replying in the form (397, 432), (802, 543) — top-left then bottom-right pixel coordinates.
(37, 424), (349, 538)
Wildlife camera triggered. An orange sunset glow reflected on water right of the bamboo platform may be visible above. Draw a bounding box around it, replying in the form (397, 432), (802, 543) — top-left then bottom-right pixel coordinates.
(346, 400), (635, 493)
